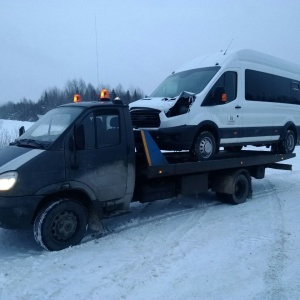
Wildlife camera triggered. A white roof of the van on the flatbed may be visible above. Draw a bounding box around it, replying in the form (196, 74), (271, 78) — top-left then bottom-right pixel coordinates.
(175, 49), (300, 74)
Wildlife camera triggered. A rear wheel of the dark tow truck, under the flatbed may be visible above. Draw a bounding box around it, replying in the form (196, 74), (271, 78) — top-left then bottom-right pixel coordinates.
(224, 173), (250, 204)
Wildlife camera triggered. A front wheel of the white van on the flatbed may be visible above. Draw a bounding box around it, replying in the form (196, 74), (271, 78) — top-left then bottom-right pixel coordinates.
(194, 131), (216, 160)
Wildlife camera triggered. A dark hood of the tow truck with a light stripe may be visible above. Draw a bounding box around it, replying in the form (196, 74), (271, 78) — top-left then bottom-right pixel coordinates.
(0, 146), (45, 174)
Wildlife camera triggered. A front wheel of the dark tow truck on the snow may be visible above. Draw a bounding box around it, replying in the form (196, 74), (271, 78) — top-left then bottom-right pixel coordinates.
(33, 199), (88, 251)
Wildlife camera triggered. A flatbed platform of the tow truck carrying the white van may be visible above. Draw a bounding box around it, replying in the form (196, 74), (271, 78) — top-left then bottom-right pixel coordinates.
(136, 131), (296, 179)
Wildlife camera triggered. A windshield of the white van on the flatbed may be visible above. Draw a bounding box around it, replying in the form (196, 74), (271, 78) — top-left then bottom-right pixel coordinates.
(150, 66), (220, 98)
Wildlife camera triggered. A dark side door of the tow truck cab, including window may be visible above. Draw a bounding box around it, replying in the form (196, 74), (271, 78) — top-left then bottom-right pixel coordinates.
(66, 108), (128, 201)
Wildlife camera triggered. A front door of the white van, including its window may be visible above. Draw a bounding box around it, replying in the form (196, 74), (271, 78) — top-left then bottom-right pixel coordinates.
(202, 70), (243, 144)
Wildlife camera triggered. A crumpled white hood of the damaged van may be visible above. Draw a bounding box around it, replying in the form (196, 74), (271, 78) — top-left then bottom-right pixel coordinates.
(129, 92), (196, 113)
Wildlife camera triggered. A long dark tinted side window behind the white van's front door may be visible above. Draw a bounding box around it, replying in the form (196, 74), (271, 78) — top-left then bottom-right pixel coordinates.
(245, 69), (300, 104)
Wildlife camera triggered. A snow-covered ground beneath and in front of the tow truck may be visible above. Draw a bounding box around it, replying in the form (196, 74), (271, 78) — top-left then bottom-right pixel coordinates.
(0, 119), (300, 300)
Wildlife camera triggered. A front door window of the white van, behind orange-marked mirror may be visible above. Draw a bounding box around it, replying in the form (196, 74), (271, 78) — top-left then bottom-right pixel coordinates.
(202, 71), (237, 106)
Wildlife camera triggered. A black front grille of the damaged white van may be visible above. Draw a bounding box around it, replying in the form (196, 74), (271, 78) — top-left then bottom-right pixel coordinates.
(130, 108), (160, 128)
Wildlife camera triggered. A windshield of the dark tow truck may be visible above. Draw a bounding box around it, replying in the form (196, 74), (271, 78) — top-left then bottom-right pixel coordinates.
(15, 106), (83, 148)
